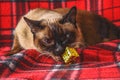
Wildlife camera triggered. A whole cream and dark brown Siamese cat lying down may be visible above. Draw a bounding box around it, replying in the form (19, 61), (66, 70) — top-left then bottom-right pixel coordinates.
(9, 7), (120, 61)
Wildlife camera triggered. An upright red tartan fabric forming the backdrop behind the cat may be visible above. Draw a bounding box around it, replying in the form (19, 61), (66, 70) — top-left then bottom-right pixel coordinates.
(0, 0), (120, 47)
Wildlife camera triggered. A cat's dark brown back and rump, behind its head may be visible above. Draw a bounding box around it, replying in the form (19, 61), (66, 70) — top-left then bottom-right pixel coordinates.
(55, 9), (120, 45)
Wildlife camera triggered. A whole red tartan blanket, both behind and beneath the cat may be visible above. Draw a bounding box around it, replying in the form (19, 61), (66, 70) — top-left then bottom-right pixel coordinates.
(0, 0), (120, 80)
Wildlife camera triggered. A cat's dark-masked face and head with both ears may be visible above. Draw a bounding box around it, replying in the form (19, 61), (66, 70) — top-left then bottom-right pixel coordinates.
(24, 7), (84, 55)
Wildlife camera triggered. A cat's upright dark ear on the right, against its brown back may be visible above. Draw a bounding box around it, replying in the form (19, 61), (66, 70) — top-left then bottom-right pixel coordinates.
(61, 6), (77, 24)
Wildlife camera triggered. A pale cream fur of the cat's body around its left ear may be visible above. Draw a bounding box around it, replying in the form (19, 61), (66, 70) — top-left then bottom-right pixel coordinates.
(15, 8), (62, 50)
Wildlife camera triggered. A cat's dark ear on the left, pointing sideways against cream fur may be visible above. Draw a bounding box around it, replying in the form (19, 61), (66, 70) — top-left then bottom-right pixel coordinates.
(23, 17), (42, 33)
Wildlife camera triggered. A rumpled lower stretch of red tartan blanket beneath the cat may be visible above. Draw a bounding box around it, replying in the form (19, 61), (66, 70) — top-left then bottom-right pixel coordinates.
(0, 40), (120, 80)
